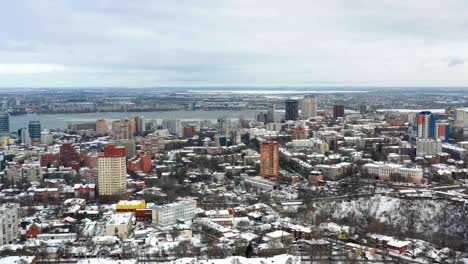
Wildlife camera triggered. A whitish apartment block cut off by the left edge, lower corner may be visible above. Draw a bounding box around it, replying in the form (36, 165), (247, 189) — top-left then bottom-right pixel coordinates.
(0, 203), (19, 246)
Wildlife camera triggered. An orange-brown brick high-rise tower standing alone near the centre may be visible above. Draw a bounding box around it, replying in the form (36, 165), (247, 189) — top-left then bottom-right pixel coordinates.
(260, 142), (279, 177)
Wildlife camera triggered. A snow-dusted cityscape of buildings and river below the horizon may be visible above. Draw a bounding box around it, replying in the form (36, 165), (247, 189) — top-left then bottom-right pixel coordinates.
(0, 88), (468, 263)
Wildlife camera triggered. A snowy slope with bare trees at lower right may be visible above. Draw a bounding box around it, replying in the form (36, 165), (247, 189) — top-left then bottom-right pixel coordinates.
(311, 195), (468, 244)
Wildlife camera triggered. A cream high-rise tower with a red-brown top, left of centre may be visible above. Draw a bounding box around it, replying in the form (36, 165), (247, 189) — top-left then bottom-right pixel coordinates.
(98, 145), (127, 198)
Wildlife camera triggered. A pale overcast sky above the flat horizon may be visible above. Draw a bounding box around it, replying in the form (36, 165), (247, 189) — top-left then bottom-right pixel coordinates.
(0, 0), (468, 87)
